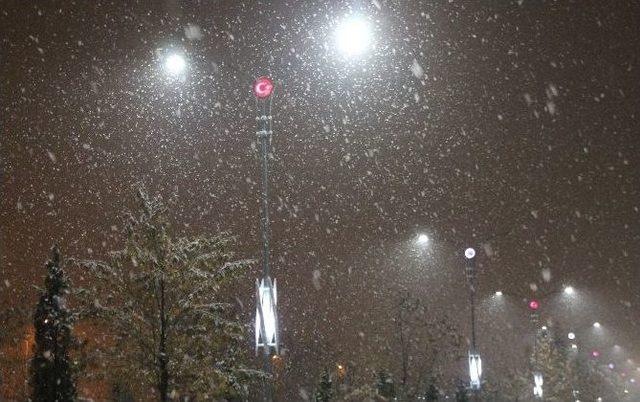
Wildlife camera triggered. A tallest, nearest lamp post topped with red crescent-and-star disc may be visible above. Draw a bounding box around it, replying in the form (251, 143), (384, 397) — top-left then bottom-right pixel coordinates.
(253, 77), (279, 401)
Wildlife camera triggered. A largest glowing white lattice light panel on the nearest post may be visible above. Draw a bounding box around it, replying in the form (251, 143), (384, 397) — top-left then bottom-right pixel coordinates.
(256, 277), (278, 354)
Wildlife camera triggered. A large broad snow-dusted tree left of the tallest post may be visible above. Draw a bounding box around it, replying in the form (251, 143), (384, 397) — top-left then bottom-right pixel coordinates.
(77, 190), (262, 402)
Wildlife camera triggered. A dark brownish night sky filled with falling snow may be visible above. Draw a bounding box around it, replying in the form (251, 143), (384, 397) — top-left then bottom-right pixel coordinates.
(0, 0), (640, 396)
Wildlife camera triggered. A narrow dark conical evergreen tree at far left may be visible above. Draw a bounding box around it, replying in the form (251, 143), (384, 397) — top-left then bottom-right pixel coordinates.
(31, 246), (76, 402)
